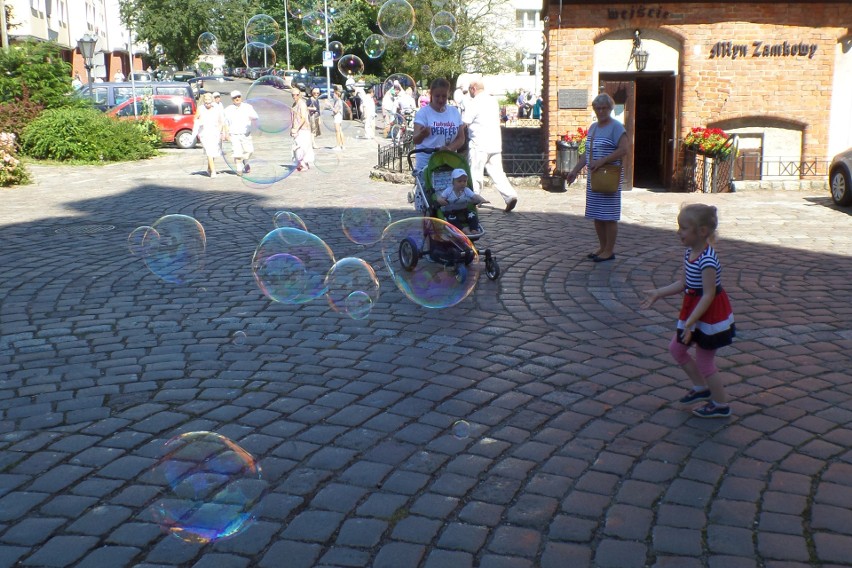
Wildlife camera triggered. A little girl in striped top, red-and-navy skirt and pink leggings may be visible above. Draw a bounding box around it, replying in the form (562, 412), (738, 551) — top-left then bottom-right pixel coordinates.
(642, 203), (736, 418)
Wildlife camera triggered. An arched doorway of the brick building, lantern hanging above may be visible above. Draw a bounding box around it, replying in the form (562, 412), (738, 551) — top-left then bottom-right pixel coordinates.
(594, 30), (682, 188)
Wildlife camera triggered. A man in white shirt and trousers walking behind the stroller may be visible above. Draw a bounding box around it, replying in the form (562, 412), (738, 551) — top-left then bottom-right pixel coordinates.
(462, 77), (518, 213)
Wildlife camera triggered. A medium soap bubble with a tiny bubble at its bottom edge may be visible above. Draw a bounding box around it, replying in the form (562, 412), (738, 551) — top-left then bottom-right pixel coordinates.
(325, 257), (379, 319)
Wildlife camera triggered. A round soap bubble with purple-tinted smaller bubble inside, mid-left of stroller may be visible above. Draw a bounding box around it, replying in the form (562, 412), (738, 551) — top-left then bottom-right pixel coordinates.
(251, 227), (334, 304)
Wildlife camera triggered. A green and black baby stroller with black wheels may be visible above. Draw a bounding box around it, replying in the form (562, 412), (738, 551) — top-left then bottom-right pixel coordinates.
(399, 148), (500, 280)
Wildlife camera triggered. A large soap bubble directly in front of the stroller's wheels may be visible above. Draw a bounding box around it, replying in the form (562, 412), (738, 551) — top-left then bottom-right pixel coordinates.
(382, 217), (480, 308)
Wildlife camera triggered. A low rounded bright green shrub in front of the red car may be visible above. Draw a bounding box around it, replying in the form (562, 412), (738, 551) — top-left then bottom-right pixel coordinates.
(21, 108), (156, 162)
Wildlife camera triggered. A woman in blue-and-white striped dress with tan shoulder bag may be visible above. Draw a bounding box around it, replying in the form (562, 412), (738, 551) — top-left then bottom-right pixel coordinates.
(566, 93), (630, 262)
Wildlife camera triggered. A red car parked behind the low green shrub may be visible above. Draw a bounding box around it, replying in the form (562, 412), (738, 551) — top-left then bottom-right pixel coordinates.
(107, 95), (195, 149)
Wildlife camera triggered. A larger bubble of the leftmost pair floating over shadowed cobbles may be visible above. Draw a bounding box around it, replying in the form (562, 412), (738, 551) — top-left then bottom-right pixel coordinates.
(142, 215), (207, 284)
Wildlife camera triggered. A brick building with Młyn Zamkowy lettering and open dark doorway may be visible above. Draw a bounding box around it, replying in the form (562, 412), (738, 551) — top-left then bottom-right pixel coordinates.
(543, 0), (852, 188)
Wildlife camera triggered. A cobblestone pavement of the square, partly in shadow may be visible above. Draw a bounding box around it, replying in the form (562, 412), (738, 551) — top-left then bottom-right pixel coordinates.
(0, 117), (852, 568)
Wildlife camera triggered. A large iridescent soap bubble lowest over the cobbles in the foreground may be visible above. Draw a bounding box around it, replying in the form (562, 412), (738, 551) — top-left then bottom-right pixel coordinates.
(149, 432), (269, 544)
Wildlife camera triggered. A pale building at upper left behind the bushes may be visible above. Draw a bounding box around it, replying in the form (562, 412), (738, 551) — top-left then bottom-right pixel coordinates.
(5, 0), (145, 82)
